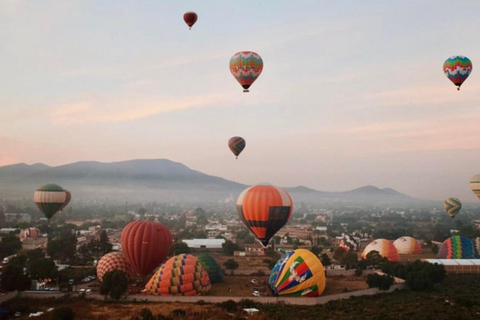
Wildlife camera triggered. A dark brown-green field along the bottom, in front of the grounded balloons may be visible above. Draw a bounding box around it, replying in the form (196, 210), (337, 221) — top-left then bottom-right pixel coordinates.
(4, 275), (480, 320)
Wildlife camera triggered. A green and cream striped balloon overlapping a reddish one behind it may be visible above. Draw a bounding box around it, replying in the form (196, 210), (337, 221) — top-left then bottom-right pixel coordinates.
(33, 184), (67, 219)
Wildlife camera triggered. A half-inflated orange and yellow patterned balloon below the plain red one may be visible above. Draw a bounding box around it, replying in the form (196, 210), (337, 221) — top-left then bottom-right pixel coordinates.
(145, 254), (210, 296)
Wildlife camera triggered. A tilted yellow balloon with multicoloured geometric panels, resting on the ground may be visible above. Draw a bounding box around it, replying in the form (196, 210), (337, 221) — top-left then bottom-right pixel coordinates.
(268, 249), (325, 297)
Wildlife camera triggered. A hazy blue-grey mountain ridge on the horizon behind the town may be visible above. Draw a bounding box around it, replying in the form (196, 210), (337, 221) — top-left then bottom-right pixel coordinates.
(0, 159), (415, 203)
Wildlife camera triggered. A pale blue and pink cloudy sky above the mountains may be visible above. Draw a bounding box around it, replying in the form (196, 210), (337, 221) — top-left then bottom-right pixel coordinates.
(0, 0), (480, 202)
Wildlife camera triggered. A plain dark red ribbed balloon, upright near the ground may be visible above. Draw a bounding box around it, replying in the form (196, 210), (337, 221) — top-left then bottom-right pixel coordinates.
(121, 221), (172, 277)
